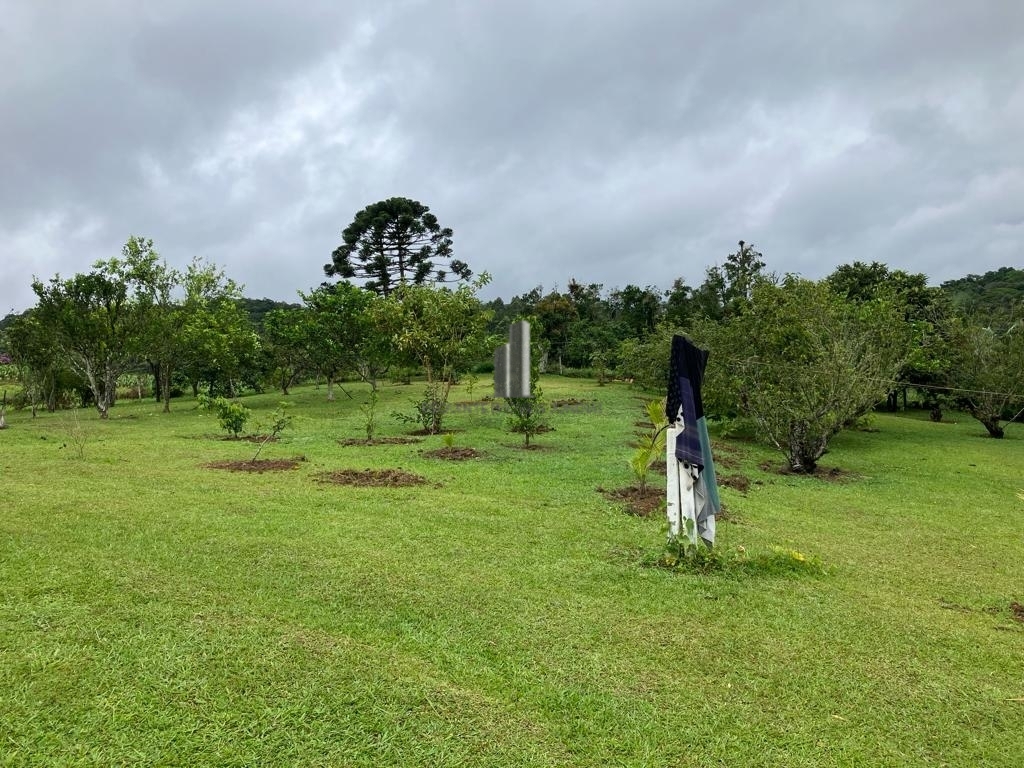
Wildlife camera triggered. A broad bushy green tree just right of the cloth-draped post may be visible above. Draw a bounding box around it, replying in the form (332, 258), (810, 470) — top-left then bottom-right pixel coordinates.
(693, 275), (909, 472)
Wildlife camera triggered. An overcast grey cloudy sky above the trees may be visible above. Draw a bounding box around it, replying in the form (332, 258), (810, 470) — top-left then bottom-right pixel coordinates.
(0, 0), (1024, 315)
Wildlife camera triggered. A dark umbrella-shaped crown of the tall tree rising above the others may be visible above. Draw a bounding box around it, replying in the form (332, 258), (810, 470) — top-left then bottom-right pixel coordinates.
(324, 198), (472, 296)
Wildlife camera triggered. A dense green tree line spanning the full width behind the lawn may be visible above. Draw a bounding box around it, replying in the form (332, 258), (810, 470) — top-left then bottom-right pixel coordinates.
(0, 198), (1024, 471)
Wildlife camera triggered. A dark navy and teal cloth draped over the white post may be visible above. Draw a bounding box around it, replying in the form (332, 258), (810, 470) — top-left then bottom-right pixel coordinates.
(665, 336), (721, 520)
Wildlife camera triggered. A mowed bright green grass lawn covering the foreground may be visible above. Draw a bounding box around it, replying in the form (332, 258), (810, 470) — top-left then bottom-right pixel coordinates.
(0, 377), (1024, 766)
